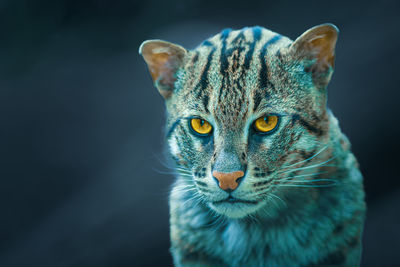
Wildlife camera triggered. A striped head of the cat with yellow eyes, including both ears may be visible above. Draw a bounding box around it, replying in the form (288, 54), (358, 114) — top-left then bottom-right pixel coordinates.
(140, 24), (338, 218)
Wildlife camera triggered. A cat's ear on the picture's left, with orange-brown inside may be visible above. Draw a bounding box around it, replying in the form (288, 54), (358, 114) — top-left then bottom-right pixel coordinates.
(139, 40), (187, 99)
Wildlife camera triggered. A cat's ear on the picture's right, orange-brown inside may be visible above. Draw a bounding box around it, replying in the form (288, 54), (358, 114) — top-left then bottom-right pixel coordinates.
(290, 23), (339, 86)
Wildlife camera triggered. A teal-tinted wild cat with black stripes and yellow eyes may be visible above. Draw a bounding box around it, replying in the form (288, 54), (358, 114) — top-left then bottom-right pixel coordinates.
(139, 24), (366, 267)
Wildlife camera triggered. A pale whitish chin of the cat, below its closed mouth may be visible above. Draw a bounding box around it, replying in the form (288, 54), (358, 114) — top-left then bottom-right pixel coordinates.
(208, 202), (263, 219)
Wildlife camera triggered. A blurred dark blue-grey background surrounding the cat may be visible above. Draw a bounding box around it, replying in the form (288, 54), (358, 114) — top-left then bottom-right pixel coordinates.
(0, 0), (400, 266)
